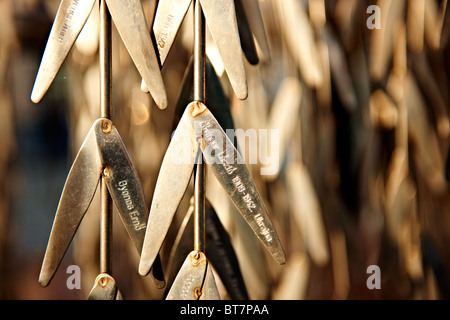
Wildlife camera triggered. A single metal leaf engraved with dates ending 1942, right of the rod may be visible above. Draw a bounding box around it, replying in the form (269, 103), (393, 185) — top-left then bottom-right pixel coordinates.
(187, 102), (286, 264)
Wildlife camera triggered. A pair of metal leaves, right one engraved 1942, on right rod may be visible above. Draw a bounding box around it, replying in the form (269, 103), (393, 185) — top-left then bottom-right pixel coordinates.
(139, 102), (286, 275)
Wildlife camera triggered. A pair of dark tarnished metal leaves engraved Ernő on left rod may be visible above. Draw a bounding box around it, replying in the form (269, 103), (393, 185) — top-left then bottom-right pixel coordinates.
(39, 119), (165, 287)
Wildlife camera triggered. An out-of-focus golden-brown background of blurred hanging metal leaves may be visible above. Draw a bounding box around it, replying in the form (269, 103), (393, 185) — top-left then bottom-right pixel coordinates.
(0, 0), (450, 300)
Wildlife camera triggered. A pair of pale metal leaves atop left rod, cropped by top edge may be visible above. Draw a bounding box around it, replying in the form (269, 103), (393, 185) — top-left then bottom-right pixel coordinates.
(31, 0), (168, 109)
